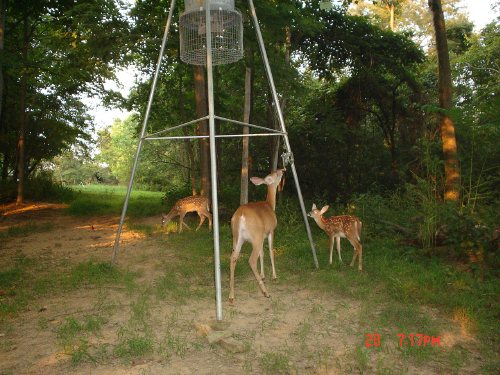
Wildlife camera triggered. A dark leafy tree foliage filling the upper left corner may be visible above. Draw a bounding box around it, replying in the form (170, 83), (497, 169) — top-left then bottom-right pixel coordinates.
(0, 0), (128, 180)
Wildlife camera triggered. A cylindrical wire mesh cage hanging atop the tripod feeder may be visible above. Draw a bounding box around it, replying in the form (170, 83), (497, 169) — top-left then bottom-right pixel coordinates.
(179, 0), (243, 65)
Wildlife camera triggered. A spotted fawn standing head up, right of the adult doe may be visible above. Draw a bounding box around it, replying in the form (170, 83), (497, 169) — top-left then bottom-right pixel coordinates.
(307, 204), (363, 271)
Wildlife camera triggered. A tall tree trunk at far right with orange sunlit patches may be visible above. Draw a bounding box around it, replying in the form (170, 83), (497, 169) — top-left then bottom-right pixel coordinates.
(429, 0), (460, 202)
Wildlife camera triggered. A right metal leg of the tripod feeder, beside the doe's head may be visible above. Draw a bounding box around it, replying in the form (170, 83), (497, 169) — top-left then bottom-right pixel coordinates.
(248, 0), (319, 268)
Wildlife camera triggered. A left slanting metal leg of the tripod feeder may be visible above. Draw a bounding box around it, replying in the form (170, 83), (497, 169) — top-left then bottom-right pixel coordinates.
(111, 0), (175, 264)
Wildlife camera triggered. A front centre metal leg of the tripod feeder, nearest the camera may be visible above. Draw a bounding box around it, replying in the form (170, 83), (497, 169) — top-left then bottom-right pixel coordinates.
(205, 0), (222, 321)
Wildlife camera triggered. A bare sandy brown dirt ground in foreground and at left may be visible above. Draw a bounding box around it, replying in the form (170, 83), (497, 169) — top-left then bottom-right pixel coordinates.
(0, 204), (480, 375)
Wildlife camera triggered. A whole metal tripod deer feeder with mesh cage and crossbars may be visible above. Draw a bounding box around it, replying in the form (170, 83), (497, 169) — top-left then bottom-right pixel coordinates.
(112, 0), (319, 321)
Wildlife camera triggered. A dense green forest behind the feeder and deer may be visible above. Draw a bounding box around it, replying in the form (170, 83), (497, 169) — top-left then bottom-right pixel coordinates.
(0, 0), (500, 264)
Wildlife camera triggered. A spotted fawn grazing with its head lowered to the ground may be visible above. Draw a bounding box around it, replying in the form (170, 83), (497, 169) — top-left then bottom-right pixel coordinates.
(161, 195), (212, 233)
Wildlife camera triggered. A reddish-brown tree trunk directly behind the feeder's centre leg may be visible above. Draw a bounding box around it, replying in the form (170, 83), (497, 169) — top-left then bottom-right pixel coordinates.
(194, 65), (211, 197)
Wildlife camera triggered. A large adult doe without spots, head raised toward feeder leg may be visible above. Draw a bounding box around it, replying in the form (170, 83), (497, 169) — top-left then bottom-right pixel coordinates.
(229, 169), (284, 303)
